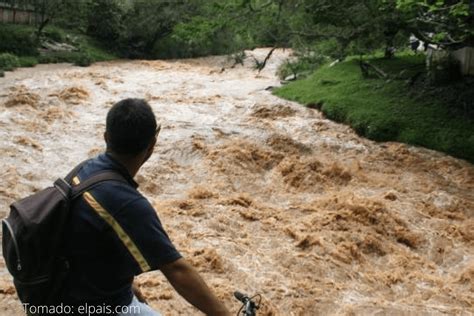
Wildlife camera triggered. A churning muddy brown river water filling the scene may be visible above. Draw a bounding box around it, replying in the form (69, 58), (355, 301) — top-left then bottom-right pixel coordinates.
(0, 49), (474, 315)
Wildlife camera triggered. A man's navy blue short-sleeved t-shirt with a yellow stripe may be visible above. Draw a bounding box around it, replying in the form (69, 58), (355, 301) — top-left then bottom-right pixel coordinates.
(62, 154), (181, 312)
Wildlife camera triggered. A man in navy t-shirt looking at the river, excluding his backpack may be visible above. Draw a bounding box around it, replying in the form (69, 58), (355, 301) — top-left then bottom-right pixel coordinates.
(61, 99), (229, 315)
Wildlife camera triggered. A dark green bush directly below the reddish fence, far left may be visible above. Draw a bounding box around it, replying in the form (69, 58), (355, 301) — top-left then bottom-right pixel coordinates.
(0, 24), (38, 56)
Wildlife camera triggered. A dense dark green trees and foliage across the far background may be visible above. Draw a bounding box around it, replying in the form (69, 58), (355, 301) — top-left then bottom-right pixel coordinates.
(0, 0), (474, 58)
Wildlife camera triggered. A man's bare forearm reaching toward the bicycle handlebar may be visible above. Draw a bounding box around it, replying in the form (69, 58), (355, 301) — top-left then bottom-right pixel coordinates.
(160, 258), (230, 316)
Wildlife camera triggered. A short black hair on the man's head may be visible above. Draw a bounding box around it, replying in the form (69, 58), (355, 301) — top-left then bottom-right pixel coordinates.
(106, 99), (156, 154)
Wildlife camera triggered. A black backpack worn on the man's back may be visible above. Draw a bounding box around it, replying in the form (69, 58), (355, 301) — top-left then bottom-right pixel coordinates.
(2, 161), (126, 306)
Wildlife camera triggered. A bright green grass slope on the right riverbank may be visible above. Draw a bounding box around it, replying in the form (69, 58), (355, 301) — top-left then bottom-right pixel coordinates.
(274, 56), (474, 162)
